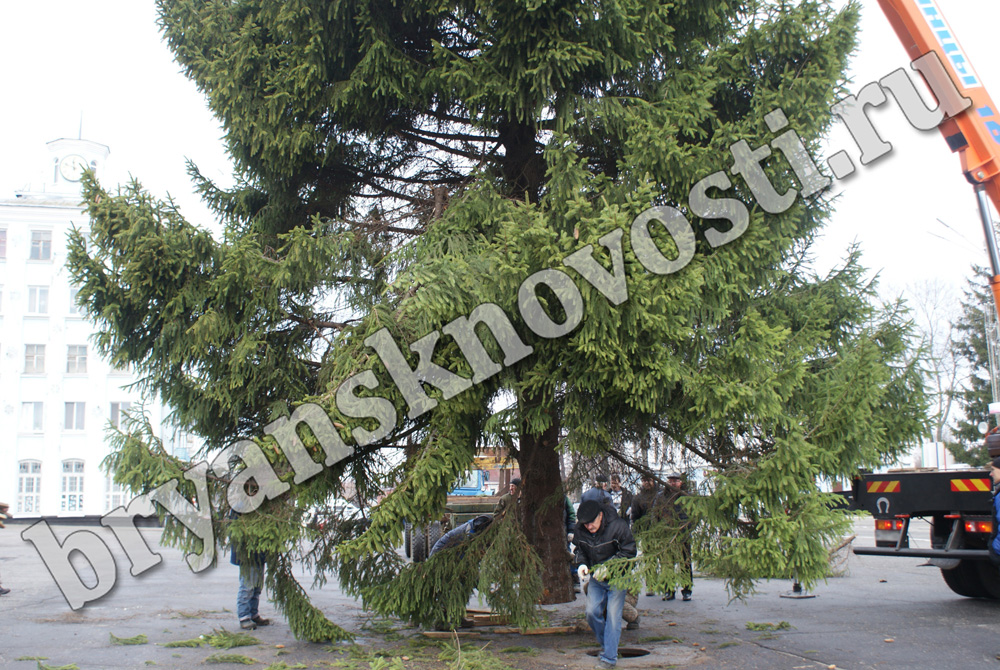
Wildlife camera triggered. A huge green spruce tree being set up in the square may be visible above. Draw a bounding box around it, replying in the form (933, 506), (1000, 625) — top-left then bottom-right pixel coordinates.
(70, 0), (925, 639)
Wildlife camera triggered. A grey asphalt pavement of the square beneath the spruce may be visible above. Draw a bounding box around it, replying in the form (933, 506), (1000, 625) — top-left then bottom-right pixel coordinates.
(0, 520), (1000, 670)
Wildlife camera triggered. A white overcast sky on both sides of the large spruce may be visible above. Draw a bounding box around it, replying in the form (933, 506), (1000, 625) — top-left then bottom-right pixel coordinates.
(0, 0), (1000, 304)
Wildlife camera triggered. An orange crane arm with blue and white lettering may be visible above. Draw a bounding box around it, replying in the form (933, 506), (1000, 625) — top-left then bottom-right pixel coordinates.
(878, 0), (1000, 312)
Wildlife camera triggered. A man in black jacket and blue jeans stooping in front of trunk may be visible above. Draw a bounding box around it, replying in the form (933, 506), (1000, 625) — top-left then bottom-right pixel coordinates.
(573, 500), (636, 670)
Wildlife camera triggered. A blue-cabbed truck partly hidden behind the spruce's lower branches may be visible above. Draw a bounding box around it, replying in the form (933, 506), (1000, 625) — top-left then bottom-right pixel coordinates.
(403, 456), (517, 563)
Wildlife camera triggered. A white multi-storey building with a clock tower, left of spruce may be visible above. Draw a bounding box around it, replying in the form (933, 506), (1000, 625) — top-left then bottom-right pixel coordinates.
(0, 139), (194, 517)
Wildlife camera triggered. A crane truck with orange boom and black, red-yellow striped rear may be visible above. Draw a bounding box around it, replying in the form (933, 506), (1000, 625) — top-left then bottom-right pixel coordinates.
(853, 0), (1000, 600)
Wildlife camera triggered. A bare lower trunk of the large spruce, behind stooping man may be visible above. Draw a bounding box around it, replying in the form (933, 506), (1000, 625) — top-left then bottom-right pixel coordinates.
(518, 406), (575, 605)
